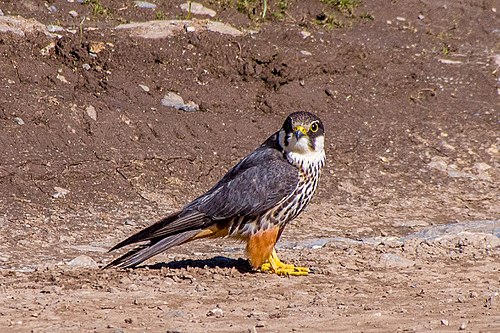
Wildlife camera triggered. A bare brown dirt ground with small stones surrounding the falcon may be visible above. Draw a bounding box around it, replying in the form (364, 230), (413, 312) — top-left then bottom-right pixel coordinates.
(0, 0), (500, 333)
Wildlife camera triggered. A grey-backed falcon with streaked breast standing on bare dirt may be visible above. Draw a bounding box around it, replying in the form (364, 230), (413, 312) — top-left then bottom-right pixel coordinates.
(105, 111), (325, 275)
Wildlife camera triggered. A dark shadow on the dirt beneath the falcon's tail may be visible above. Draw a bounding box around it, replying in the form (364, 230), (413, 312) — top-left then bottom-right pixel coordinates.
(141, 256), (254, 273)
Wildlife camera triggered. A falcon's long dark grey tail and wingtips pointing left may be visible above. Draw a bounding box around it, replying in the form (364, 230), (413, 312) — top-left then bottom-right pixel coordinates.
(103, 212), (212, 269)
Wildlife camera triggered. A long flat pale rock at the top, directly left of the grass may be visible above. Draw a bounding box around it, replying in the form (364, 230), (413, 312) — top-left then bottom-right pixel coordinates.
(115, 20), (243, 39)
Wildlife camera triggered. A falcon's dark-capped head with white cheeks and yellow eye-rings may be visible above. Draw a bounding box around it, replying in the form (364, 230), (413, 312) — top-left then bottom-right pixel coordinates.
(279, 111), (325, 158)
